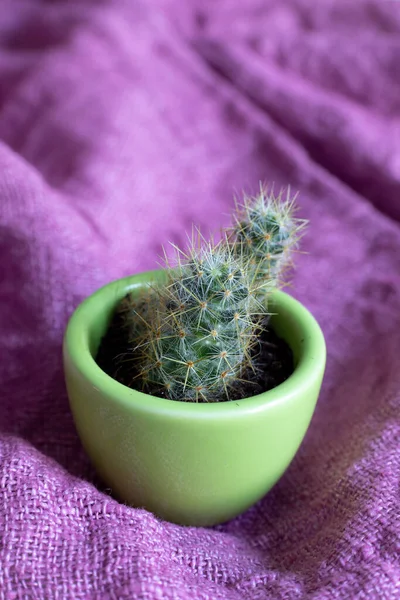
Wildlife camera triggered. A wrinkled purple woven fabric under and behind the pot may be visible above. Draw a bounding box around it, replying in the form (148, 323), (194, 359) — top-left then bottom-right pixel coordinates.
(0, 0), (400, 600)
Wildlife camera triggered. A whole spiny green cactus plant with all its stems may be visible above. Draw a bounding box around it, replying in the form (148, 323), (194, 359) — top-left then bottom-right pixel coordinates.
(121, 187), (306, 402)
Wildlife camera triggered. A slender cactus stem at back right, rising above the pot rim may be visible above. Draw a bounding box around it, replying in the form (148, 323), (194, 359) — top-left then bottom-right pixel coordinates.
(227, 186), (307, 301)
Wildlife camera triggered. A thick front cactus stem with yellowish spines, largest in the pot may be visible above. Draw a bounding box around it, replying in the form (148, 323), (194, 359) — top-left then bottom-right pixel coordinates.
(128, 240), (266, 402)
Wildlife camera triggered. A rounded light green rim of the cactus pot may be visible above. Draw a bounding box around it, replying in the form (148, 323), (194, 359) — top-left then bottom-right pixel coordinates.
(63, 270), (326, 419)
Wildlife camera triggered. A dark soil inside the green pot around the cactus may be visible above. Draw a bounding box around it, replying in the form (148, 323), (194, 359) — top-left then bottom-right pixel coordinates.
(96, 296), (294, 400)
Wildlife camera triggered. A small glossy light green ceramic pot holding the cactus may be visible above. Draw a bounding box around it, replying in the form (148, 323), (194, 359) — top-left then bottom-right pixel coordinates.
(64, 271), (326, 526)
